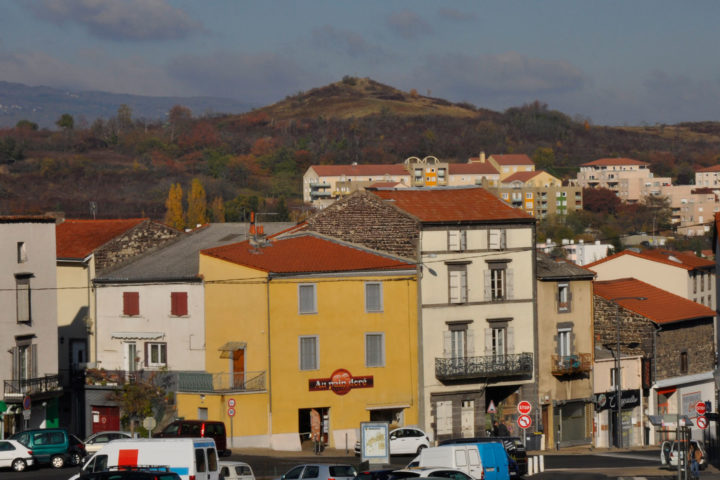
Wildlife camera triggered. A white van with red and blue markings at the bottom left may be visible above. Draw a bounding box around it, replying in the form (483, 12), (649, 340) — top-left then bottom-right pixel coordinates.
(70, 438), (220, 480)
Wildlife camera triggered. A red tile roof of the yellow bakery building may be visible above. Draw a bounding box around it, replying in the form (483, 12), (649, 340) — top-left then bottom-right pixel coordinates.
(200, 233), (415, 273)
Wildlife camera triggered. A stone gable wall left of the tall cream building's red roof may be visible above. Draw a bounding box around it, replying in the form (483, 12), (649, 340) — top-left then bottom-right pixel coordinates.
(307, 192), (420, 258)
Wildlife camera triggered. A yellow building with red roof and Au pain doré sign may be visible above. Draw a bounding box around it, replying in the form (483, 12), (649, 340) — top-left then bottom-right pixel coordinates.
(194, 234), (418, 450)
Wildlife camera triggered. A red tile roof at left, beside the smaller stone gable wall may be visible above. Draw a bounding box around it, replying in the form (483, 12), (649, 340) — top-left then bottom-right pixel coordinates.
(55, 218), (147, 258)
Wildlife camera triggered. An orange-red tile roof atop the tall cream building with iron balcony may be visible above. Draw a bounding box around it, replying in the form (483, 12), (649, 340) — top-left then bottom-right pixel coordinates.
(370, 187), (533, 222)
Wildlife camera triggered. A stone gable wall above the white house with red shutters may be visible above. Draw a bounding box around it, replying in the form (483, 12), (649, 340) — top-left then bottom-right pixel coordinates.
(95, 220), (182, 272)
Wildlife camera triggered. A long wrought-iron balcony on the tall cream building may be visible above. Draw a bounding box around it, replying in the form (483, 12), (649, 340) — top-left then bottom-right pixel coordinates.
(435, 353), (533, 380)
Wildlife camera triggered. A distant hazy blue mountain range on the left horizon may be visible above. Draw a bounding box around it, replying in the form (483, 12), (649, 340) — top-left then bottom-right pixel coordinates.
(0, 81), (256, 128)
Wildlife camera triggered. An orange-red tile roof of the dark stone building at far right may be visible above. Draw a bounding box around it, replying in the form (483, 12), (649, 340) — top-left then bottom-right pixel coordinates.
(593, 278), (715, 324)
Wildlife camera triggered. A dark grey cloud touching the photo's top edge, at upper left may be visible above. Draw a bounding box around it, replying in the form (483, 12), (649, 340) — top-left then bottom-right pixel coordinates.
(26, 0), (202, 41)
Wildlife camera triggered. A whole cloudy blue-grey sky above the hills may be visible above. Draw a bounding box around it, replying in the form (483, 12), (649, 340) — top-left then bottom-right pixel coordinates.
(0, 0), (720, 125)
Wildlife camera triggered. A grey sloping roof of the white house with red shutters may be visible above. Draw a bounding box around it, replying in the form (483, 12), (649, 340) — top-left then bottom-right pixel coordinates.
(95, 222), (295, 283)
